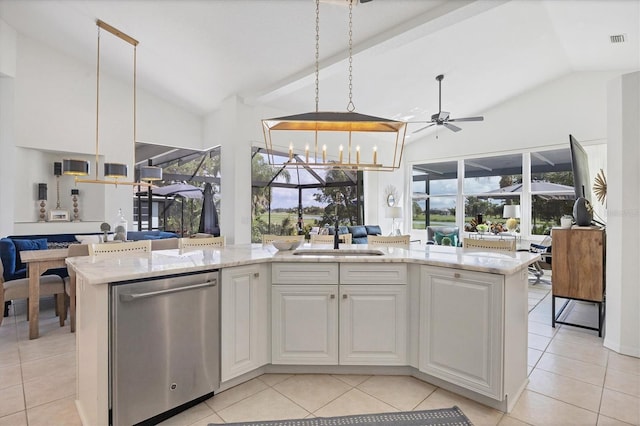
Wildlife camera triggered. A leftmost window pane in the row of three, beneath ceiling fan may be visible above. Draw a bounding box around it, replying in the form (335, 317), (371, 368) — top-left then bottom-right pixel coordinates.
(412, 161), (458, 229)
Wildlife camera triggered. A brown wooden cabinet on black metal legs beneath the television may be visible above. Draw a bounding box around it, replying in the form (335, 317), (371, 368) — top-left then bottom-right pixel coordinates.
(551, 226), (606, 337)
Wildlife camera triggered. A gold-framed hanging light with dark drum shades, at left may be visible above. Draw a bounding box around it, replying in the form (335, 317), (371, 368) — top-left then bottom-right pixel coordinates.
(63, 19), (162, 187)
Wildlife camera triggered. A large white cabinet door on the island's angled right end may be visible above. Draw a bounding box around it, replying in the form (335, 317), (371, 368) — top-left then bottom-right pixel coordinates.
(420, 266), (504, 400)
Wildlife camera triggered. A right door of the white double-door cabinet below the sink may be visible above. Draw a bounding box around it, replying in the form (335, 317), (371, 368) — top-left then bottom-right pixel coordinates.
(340, 285), (407, 365)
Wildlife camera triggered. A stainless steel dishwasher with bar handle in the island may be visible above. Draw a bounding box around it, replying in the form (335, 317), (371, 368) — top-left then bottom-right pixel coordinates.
(109, 270), (220, 425)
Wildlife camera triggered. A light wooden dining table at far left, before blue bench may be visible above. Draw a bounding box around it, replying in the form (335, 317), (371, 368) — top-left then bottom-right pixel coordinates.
(20, 249), (69, 339)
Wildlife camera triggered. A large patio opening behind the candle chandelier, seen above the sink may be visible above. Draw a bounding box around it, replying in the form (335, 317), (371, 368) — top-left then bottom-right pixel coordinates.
(251, 147), (364, 242)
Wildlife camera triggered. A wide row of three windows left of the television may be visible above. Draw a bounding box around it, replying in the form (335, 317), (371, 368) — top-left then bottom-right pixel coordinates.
(412, 148), (575, 234)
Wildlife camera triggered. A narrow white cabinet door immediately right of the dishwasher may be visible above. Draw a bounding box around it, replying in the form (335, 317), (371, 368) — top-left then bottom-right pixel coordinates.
(220, 265), (269, 382)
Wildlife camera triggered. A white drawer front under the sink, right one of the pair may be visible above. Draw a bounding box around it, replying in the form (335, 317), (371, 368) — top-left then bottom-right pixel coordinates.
(340, 263), (407, 284)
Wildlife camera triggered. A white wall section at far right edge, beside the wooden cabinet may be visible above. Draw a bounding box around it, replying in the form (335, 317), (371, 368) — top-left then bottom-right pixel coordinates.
(604, 72), (640, 357)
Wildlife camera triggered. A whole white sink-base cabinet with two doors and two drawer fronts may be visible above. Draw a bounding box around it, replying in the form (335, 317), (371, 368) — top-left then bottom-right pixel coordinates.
(271, 263), (407, 365)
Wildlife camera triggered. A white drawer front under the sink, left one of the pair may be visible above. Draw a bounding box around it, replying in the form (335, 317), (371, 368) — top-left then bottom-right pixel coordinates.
(271, 262), (338, 284)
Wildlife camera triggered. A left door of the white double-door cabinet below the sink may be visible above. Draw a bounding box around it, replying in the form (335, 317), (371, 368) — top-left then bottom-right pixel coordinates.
(271, 285), (338, 365)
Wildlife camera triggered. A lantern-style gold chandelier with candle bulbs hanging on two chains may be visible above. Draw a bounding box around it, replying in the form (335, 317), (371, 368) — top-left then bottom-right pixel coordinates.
(262, 0), (407, 171)
